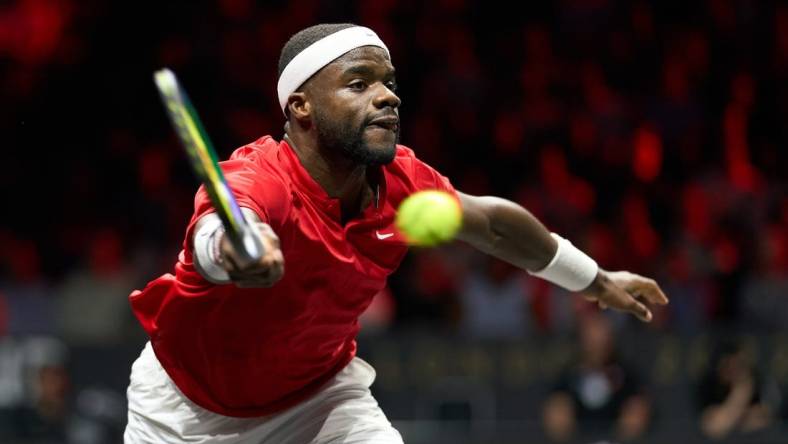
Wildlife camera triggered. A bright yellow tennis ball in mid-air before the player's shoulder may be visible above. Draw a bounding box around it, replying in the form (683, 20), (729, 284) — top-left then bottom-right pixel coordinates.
(394, 190), (462, 247)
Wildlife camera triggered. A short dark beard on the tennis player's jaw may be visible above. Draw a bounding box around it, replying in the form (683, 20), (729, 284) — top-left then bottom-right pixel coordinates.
(315, 112), (399, 166)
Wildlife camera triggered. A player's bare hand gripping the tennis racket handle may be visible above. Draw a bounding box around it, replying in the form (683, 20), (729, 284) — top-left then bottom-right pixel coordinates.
(219, 222), (285, 288)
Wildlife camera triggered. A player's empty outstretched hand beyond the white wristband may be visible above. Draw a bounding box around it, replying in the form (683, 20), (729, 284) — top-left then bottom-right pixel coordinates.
(583, 268), (668, 322)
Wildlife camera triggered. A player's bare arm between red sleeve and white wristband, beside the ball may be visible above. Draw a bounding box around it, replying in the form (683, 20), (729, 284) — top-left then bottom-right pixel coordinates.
(452, 194), (558, 271)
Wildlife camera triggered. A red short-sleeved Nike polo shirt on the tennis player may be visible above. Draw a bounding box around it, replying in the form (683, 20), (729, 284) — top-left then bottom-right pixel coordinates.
(130, 136), (455, 417)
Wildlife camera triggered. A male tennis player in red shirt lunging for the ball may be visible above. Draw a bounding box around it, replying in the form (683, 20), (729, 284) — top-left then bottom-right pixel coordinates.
(125, 24), (667, 444)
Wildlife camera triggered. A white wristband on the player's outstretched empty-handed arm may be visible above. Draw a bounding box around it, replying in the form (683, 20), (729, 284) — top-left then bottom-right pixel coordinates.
(528, 233), (599, 291)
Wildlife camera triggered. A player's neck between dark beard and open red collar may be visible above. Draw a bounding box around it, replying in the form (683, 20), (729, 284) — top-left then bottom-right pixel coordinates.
(285, 134), (374, 222)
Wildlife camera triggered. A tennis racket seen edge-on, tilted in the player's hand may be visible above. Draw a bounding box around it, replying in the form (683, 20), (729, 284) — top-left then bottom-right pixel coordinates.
(153, 68), (263, 262)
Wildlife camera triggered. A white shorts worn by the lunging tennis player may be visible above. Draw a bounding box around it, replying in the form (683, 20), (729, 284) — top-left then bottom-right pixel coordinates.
(124, 342), (402, 444)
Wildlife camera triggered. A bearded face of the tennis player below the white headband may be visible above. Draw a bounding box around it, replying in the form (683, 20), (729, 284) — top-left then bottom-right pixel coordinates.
(305, 46), (400, 165)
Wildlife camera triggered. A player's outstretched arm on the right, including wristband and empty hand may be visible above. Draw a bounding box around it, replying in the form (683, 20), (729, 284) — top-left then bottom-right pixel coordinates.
(457, 192), (668, 322)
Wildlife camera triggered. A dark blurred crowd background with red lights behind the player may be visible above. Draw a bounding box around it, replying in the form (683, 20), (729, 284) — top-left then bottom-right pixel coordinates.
(0, 0), (788, 444)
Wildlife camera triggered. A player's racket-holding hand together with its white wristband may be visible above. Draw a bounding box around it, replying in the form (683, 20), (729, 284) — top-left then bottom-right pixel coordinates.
(190, 208), (284, 288)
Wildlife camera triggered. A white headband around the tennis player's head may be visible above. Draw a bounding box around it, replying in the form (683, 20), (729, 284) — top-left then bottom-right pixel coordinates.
(276, 26), (391, 112)
